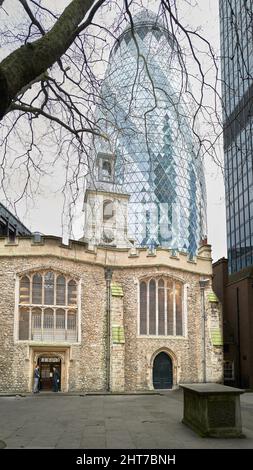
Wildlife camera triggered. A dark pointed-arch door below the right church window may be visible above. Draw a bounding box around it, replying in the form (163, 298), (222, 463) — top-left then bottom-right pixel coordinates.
(153, 352), (173, 389)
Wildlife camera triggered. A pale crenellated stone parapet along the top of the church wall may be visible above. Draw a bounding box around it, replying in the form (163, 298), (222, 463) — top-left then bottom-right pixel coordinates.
(0, 235), (212, 276)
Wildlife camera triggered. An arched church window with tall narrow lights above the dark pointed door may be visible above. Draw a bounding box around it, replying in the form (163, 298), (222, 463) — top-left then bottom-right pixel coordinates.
(139, 277), (184, 336)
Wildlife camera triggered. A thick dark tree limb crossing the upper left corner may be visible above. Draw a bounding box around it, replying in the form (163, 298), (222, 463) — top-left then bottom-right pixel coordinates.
(0, 0), (95, 119)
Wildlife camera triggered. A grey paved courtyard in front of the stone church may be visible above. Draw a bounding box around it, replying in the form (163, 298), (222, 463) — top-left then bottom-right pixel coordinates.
(0, 391), (253, 449)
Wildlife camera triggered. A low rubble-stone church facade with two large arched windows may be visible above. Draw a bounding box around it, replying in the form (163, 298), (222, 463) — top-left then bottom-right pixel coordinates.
(0, 236), (223, 392)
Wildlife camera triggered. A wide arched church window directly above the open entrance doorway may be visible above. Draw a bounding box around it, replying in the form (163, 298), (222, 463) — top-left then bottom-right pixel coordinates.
(18, 271), (78, 342)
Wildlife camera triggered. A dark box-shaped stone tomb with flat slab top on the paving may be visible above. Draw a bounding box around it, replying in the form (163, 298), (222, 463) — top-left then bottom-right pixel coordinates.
(180, 383), (244, 438)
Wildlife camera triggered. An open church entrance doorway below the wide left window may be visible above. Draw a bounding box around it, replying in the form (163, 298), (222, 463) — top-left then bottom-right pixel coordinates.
(38, 356), (61, 392)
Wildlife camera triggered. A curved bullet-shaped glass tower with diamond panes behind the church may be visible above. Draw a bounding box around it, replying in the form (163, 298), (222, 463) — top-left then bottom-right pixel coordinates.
(96, 10), (206, 255)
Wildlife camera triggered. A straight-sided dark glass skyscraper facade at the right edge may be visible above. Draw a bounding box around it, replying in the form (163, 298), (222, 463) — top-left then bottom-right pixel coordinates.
(220, 0), (253, 273)
